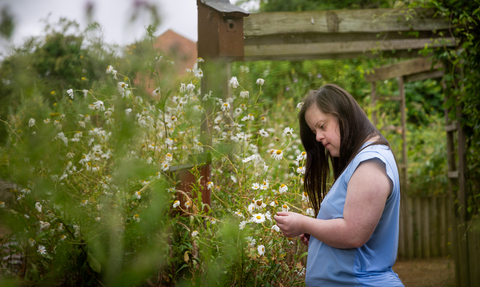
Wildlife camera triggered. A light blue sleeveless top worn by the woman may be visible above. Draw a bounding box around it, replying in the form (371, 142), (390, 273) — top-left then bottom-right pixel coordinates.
(305, 143), (404, 287)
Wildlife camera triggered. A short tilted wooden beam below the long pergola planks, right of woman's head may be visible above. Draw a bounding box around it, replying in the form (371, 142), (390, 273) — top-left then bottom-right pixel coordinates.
(364, 57), (444, 82)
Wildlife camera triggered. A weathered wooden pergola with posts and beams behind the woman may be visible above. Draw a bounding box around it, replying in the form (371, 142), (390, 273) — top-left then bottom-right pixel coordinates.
(191, 0), (455, 207)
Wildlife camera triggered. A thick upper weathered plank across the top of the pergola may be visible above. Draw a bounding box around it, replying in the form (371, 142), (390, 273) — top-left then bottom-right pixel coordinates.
(244, 9), (450, 37)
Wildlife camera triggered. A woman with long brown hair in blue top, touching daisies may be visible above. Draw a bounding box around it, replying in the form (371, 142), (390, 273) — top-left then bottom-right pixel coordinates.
(274, 85), (403, 286)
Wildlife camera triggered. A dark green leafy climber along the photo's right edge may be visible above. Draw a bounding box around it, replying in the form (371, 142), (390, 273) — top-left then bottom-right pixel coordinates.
(412, 0), (480, 214)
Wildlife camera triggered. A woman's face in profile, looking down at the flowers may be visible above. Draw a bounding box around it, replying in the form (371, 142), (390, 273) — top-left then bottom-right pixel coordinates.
(305, 104), (340, 157)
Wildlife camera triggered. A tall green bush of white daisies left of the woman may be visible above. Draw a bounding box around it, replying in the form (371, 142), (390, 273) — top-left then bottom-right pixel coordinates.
(0, 51), (313, 286)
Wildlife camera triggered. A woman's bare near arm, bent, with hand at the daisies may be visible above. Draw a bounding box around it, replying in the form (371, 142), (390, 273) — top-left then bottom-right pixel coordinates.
(274, 160), (392, 248)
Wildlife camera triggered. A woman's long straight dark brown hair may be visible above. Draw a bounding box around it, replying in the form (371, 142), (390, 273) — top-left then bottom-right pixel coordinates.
(298, 84), (390, 215)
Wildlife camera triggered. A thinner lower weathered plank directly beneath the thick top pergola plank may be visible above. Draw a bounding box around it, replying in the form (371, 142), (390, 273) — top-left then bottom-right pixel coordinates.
(245, 38), (454, 60)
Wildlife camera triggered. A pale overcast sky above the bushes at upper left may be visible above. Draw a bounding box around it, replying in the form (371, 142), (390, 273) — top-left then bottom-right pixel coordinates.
(0, 0), (258, 58)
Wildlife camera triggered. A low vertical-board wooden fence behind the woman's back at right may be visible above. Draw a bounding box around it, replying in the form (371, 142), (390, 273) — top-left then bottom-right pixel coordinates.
(398, 194), (455, 259)
